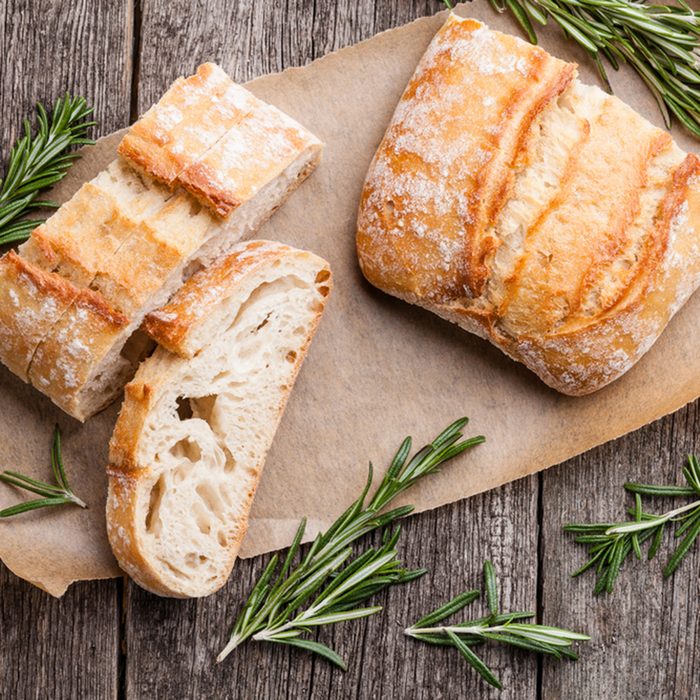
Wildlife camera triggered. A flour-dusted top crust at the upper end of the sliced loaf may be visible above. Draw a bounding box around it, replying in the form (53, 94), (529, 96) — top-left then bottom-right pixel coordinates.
(119, 64), (321, 218)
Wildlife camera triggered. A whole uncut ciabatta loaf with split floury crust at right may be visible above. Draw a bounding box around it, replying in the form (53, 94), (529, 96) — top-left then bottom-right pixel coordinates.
(357, 15), (700, 395)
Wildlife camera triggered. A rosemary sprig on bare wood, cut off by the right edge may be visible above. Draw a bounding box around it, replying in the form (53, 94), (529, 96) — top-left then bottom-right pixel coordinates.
(564, 455), (700, 594)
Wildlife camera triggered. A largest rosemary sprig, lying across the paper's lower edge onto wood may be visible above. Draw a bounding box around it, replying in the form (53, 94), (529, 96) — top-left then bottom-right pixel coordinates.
(217, 418), (484, 669)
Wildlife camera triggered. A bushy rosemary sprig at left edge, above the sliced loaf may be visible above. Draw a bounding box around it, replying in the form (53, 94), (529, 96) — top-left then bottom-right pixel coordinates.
(0, 94), (96, 244)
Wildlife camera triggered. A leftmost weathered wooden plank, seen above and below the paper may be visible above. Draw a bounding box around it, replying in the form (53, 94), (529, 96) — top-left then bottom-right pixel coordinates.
(0, 0), (132, 698)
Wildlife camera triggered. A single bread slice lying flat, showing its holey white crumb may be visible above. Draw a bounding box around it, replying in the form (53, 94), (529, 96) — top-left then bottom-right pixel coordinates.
(107, 241), (331, 597)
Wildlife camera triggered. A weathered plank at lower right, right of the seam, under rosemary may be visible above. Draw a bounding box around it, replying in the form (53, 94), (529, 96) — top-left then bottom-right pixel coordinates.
(542, 402), (700, 700)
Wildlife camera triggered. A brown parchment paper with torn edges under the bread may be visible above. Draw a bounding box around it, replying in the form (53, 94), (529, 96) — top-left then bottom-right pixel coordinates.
(0, 5), (700, 595)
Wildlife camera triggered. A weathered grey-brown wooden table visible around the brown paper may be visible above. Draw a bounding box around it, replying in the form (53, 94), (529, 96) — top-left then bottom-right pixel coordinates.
(0, 0), (700, 700)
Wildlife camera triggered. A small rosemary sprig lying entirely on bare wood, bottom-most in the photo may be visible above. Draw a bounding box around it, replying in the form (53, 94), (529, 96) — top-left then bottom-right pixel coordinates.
(404, 560), (590, 689)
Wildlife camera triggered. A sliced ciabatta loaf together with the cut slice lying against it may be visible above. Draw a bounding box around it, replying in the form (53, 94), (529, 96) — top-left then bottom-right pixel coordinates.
(0, 64), (331, 597)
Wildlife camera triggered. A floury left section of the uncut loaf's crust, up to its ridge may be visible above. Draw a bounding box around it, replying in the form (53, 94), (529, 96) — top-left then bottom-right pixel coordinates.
(357, 16), (575, 301)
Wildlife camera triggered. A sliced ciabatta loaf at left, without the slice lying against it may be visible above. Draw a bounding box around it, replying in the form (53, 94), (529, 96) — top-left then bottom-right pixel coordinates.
(0, 64), (322, 420)
